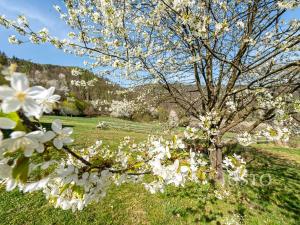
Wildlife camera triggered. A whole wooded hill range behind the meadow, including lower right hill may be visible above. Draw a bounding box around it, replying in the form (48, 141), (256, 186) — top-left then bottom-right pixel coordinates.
(0, 52), (187, 120)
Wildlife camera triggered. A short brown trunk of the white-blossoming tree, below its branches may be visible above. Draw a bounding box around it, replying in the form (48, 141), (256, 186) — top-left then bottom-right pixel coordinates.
(210, 147), (224, 184)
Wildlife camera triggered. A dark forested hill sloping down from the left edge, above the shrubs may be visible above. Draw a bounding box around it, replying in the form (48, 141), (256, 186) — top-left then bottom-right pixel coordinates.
(0, 52), (122, 100)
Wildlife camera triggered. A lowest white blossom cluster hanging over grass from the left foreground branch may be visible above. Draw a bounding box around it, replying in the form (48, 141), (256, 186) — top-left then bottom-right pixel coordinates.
(43, 161), (112, 211)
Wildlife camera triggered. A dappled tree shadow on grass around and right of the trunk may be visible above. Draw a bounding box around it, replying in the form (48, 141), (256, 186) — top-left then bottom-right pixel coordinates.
(166, 145), (300, 225)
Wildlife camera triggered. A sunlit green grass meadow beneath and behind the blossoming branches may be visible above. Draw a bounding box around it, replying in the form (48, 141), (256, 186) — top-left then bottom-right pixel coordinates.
(0, 117), (300, 225)
